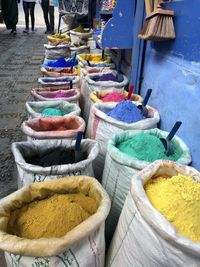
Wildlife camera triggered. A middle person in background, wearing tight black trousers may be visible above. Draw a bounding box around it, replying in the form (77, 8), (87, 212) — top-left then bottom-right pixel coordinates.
(23, 0), (36, 33)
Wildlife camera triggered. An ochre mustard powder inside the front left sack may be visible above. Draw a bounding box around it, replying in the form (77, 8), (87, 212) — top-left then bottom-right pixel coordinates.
(8, 193), (97, 239)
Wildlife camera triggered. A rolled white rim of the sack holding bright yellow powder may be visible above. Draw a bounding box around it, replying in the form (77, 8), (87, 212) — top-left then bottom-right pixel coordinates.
(130, 160), (200, 258)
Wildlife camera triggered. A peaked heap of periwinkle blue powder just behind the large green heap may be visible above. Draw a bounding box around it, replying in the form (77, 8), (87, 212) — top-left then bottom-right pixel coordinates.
(107, 100), (146, 123)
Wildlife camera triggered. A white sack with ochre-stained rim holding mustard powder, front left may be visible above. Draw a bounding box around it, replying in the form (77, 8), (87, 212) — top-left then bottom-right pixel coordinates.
(0, 176), (110, 267)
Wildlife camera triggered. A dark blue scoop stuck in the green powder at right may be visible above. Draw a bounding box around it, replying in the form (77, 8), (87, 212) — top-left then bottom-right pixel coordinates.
(160, 121), (182, 156)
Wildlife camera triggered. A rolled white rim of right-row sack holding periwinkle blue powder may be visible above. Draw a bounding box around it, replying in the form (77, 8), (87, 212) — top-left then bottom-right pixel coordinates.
(91, 101), (160, 130)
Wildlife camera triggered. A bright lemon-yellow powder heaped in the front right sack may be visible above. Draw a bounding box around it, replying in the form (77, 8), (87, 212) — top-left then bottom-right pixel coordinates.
(144, 174), (200, 242)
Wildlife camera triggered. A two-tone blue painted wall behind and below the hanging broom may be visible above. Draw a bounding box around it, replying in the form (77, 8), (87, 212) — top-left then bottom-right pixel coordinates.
(141, 0), (200, 170)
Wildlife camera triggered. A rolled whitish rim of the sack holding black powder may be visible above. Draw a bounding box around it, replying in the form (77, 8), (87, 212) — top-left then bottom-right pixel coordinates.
(11, 139), (100, 175)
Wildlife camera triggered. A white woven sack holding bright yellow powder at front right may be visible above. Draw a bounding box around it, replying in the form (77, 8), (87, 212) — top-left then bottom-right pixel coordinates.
(106, 160), (200, 267)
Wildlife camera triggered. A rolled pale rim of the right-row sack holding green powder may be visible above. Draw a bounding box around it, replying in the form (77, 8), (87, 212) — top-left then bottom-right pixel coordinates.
(107, 128), (192, 170)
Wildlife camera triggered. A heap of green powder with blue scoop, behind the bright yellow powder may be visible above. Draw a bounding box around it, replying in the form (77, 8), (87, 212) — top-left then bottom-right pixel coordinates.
(117, 133), (182, 162)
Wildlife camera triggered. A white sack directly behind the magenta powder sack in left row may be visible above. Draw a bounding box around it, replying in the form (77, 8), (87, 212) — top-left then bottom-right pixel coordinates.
(38, 76), (80, 89)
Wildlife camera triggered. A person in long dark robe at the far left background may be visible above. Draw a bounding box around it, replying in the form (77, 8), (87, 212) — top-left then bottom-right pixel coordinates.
(2, 0), (20, 35)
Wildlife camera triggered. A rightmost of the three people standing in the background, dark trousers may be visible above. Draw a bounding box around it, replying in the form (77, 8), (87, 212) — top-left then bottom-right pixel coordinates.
(41, 0), (55, 34)
